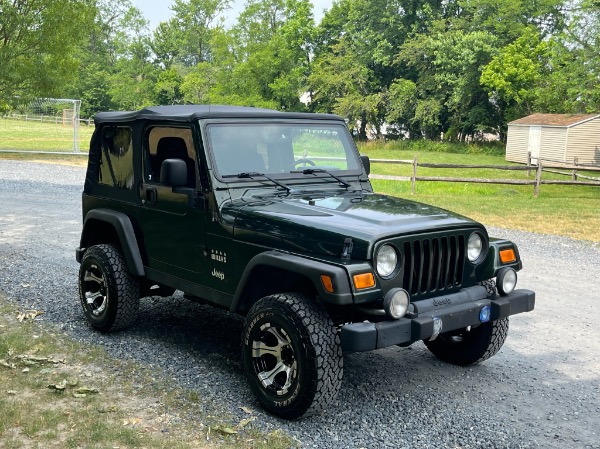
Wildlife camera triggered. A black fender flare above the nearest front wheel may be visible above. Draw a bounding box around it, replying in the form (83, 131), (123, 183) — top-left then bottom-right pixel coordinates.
(230, 251), (354, 312)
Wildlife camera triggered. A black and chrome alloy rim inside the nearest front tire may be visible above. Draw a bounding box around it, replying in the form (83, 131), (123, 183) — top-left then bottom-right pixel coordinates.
(252, 323), (298, 396)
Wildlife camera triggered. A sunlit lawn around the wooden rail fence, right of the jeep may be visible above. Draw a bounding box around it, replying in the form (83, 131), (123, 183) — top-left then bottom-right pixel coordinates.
(359, 143), (600, 243)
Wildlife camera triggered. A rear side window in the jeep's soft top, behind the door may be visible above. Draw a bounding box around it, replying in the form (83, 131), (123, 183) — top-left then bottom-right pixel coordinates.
(98, 126), (134, 190)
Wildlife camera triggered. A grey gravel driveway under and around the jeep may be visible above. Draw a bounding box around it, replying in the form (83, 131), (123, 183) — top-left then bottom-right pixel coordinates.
(0, 160), (600, 449)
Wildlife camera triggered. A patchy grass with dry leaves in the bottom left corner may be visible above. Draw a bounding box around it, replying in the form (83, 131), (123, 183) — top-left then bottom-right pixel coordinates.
(0, 295), (297, 449)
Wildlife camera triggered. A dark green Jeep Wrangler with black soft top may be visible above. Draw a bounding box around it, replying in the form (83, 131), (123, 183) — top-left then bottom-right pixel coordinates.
(77, 106), (535, 419)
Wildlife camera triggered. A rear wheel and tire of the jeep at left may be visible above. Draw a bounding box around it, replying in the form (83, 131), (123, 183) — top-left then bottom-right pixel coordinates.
(79, 244), (140, 331)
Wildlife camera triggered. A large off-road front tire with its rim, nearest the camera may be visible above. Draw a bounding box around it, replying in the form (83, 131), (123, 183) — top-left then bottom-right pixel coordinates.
(242, 293), (343, 419)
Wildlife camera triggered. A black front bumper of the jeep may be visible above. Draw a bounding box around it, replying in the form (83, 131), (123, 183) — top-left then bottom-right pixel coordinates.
(340, 286), (535, 352)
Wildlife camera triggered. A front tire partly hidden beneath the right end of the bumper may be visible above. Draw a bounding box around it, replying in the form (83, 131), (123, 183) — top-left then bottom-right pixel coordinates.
(424, 318), (508, 366)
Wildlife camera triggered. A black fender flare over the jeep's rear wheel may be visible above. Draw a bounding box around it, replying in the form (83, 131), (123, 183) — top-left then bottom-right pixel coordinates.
(80, 209), (146, 276)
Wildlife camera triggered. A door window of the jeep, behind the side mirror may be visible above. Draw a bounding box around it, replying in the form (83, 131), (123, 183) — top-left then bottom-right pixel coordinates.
(144, 126), (196, 187)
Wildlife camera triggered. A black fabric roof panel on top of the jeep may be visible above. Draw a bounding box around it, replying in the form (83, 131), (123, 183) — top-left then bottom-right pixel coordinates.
(94, 105), (343, 124)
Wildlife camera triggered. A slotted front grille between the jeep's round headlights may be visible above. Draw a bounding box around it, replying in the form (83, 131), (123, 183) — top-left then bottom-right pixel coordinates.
(402, 235), (465, 295)
